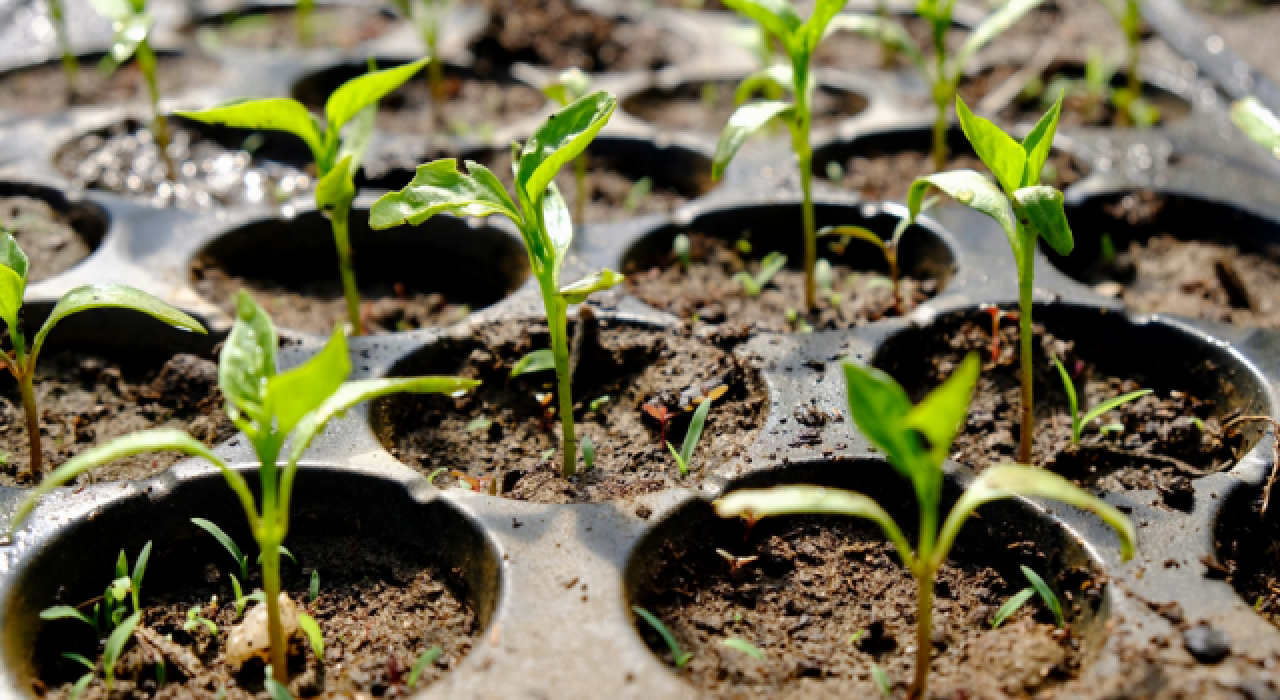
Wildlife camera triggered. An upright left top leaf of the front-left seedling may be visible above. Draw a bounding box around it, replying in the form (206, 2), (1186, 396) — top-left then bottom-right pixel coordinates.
(218, 290), (278, 433)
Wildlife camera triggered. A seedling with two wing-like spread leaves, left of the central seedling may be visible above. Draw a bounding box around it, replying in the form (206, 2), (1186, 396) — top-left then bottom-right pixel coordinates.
(178, 59), (426, 335)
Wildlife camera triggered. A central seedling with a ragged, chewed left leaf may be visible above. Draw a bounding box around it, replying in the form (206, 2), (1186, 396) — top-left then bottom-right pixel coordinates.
(369, 92), (622, 477)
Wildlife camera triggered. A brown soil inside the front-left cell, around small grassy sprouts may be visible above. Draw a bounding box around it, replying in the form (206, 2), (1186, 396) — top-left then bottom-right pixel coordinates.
(45, 536), (477, 700)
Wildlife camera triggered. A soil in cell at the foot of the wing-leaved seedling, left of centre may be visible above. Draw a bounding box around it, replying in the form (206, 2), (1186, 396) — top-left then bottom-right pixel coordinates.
(192, 263), (471, 335)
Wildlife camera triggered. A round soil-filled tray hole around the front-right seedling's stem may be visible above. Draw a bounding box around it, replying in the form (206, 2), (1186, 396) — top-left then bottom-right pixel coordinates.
(626, 461), (1108, 697)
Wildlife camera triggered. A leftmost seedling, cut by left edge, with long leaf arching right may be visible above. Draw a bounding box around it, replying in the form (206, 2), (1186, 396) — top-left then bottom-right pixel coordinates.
(0, 230), (205, 476)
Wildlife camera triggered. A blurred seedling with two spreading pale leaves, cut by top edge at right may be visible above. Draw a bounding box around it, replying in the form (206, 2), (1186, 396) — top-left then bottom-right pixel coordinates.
(831, 0), (1044, 170)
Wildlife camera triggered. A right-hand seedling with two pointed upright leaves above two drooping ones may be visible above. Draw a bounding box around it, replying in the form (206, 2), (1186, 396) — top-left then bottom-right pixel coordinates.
(906, 94), (1075, 465)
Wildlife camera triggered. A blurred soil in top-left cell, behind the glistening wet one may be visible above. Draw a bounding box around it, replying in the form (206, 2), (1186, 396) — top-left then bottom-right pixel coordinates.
(0, 54), (220, 115)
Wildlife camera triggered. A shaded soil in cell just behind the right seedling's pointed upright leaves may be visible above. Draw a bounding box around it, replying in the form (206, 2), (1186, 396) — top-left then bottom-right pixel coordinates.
(813, 127), (1089, 201)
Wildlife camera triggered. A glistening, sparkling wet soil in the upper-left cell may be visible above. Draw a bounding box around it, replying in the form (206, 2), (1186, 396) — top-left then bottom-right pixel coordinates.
(55, 119), (311, 209)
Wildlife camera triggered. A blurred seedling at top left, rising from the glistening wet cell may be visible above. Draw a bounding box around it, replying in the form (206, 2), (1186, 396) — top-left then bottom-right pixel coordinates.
(90, 0), (175, 180)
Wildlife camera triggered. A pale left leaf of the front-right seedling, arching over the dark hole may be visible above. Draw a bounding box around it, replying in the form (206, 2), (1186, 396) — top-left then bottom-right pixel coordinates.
(713, 485), (915, 568)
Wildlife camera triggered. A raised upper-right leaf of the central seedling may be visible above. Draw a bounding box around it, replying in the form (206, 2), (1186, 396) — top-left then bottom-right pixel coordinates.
(516, 91), (618, 205)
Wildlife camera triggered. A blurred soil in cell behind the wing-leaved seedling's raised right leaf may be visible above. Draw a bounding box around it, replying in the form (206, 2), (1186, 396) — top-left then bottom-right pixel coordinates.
(293, 61), (547, 142)
